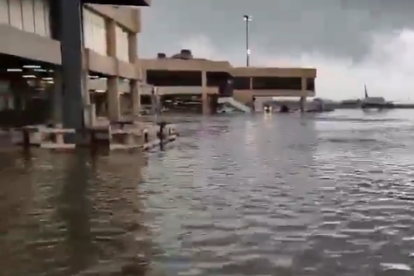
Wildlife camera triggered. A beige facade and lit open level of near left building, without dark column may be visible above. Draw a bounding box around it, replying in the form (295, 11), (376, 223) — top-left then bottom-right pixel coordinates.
(0, 0), (147, 127)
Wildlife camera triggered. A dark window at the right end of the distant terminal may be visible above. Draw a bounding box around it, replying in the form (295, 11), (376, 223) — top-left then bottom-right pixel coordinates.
(253, 77), (302, 90)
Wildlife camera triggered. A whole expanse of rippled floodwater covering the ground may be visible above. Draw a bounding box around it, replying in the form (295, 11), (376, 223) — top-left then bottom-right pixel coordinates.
(0, 110), (414, 276)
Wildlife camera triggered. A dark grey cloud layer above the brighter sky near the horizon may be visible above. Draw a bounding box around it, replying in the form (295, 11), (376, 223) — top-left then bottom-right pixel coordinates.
(140, 0), (414, 59)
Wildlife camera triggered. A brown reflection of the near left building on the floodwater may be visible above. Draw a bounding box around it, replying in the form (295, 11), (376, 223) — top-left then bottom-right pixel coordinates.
(0, 152), (150, 276)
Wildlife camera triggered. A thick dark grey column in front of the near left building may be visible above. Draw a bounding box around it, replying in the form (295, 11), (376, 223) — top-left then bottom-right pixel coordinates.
(60, 0), (85, 134)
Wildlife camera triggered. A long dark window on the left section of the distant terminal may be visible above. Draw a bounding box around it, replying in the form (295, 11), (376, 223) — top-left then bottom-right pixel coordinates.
(147, 70), (202, 86)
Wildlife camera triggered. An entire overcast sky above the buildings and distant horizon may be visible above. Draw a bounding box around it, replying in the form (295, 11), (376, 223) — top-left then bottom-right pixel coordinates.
(139, 0), (414, 101)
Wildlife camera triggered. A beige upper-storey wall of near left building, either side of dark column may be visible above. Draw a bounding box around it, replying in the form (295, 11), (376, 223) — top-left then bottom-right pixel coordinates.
(0, 0), (142, 79)
